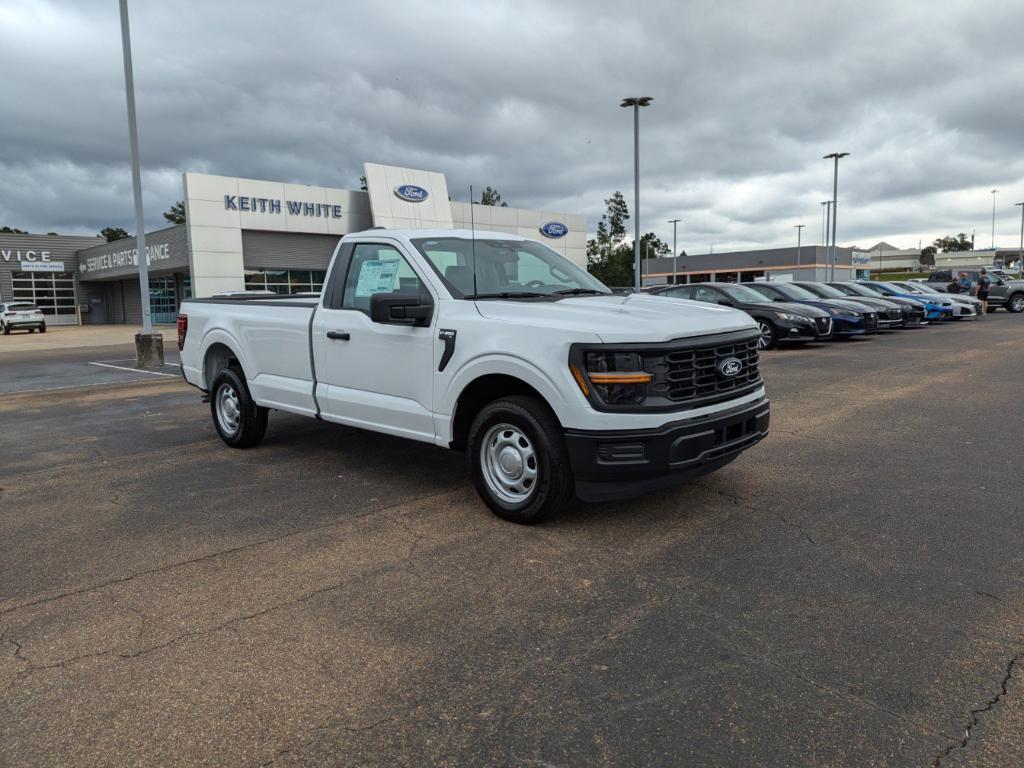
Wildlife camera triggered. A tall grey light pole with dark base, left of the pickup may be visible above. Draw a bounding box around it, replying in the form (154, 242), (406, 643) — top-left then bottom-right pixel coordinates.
(120, 0), (164, 368)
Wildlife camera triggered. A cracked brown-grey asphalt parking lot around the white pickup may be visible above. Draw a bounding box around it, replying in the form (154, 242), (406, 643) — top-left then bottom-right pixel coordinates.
(0, 312), (1024, 766)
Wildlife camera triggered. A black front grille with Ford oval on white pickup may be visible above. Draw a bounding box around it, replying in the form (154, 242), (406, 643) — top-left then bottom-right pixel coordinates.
(645, 338), (761, 404)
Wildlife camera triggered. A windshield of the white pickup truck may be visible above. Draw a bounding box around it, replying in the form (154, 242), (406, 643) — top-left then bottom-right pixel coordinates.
(413, 238), (611, 299)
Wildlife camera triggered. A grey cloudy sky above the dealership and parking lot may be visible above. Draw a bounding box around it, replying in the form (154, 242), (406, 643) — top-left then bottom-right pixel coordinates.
(0, 0), (1024, 253)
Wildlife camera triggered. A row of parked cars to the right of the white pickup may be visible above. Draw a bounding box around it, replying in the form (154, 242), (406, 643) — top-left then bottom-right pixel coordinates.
(650, 281), (995, 349)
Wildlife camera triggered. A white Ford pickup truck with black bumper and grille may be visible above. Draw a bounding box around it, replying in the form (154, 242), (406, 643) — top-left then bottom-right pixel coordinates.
(178, 229), (769, 523)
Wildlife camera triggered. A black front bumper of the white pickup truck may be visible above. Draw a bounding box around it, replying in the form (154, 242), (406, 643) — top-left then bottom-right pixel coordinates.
(565, 398), (769, 502)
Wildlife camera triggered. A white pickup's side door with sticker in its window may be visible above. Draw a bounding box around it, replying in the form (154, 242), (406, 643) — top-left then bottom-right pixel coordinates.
(311, 242), (436, 442)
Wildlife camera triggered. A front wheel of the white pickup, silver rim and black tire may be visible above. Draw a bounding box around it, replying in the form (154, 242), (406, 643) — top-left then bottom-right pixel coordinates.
(468, 395), (573, 525)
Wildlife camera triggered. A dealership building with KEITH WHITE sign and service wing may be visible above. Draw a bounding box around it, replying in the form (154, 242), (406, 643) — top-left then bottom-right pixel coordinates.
(0, 163), (587, 325)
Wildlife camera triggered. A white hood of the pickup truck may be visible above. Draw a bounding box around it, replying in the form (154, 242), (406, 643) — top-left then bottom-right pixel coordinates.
(476, 294), (757, 344)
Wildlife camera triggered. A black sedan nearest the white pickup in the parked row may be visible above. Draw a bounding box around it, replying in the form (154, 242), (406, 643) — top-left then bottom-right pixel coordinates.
(651, 283), (833, 349)
